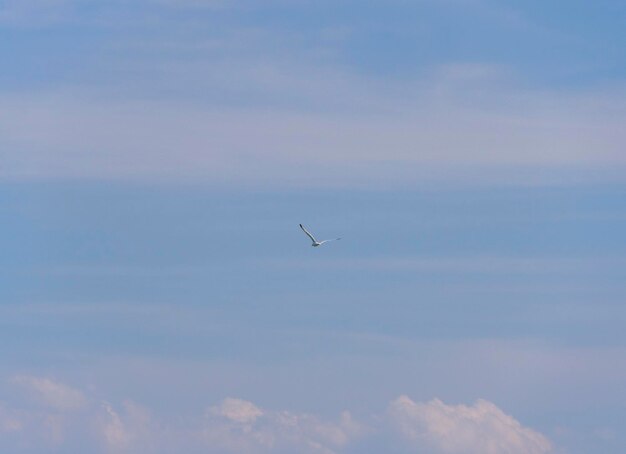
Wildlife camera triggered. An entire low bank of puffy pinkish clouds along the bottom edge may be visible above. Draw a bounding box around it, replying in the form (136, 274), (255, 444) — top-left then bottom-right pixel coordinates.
(0, 376), (552, 454)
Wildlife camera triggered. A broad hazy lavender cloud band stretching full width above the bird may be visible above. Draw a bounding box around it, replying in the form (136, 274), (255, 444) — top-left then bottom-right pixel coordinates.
(0, 76), (626, 185)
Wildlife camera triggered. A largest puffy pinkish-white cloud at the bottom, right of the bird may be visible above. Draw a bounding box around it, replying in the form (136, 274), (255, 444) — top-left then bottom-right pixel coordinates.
(388, 396), (552, 454)
